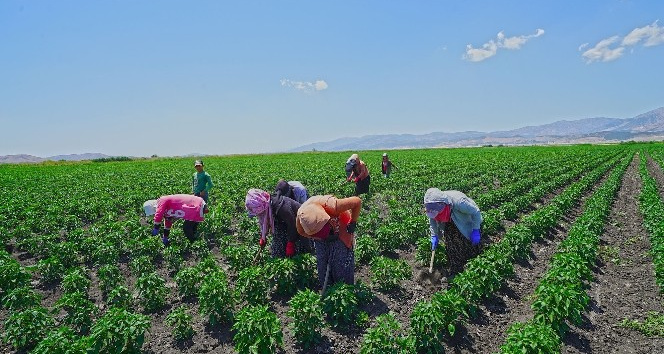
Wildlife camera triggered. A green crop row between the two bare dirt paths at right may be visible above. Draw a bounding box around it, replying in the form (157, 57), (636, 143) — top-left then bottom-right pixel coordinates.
(501, 154), (631, 353)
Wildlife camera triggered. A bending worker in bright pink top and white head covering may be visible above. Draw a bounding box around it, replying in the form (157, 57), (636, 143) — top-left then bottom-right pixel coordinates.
(143, 194), (207, 246)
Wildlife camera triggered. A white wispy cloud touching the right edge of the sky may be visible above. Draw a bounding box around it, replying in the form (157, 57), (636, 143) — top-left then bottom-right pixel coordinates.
(579, 21), (664, 64)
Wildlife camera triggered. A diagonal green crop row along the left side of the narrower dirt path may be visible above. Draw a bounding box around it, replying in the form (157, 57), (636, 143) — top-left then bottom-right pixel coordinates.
(348, 153), (628, 353)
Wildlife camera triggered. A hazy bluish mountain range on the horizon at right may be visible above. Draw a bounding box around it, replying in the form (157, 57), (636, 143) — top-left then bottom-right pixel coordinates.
(290, 107), (664, 152)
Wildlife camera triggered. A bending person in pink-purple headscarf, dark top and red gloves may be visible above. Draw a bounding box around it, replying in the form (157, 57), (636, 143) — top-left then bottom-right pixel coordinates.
(245, 182), (312, 258)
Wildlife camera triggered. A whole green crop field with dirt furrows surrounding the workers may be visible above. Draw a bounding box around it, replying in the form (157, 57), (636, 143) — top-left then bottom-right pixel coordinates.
(0, 144), (664, 353)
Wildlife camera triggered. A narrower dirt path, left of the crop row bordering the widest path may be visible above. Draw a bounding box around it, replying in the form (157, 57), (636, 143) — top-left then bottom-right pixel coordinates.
(438, 156), (612, 353)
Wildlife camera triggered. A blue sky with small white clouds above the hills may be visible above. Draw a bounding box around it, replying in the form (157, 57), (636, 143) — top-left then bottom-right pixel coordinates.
(0, 0), (664, 157)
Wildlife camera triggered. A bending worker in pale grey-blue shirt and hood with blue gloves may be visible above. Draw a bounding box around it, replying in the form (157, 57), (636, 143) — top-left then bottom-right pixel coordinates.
(424, 188), (482, 274)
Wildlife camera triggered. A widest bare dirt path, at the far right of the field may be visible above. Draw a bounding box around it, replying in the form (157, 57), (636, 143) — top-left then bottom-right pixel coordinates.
(562, 155), (664, 354)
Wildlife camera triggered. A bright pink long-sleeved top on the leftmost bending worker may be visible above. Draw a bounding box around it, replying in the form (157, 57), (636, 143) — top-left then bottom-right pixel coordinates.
(154, 194), (205, 229)
